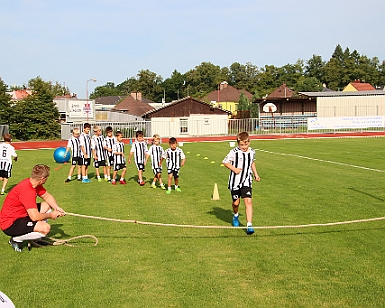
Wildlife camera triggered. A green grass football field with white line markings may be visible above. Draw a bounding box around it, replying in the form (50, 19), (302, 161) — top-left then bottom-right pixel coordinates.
(0, 138), (385, 308)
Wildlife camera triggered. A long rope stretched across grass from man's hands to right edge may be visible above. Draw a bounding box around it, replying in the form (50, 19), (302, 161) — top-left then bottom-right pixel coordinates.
(66, 212), (385, 229)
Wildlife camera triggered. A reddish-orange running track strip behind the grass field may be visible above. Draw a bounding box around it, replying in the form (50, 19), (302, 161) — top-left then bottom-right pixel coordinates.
(12, 132), (385, 150)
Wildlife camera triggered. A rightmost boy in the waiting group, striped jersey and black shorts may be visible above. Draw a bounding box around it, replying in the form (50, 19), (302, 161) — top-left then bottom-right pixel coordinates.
(159, 137), (186, 194)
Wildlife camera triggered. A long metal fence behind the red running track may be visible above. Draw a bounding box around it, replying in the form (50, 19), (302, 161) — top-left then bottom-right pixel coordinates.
(61, 116), (385, 140)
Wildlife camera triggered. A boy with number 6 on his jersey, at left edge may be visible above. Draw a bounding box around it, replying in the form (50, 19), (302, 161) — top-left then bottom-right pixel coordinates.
(0, 134), (17, 195)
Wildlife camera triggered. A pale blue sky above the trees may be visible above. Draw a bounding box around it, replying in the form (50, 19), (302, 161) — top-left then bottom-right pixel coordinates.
(0, 0), (385, 98)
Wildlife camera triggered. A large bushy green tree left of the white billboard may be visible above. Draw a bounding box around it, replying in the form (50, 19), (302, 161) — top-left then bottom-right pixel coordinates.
(10, 77), (62, 140)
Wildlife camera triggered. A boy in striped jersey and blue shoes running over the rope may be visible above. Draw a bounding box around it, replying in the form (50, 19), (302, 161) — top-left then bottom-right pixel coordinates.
(222, 132), (260, 235)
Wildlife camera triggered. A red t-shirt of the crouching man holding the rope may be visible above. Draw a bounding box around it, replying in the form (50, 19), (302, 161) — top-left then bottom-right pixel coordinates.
(0, 178), (47, 230)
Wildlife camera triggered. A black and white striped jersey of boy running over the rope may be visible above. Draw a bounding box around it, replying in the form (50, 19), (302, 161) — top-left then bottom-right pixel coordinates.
(223, 147), (255, 191)
